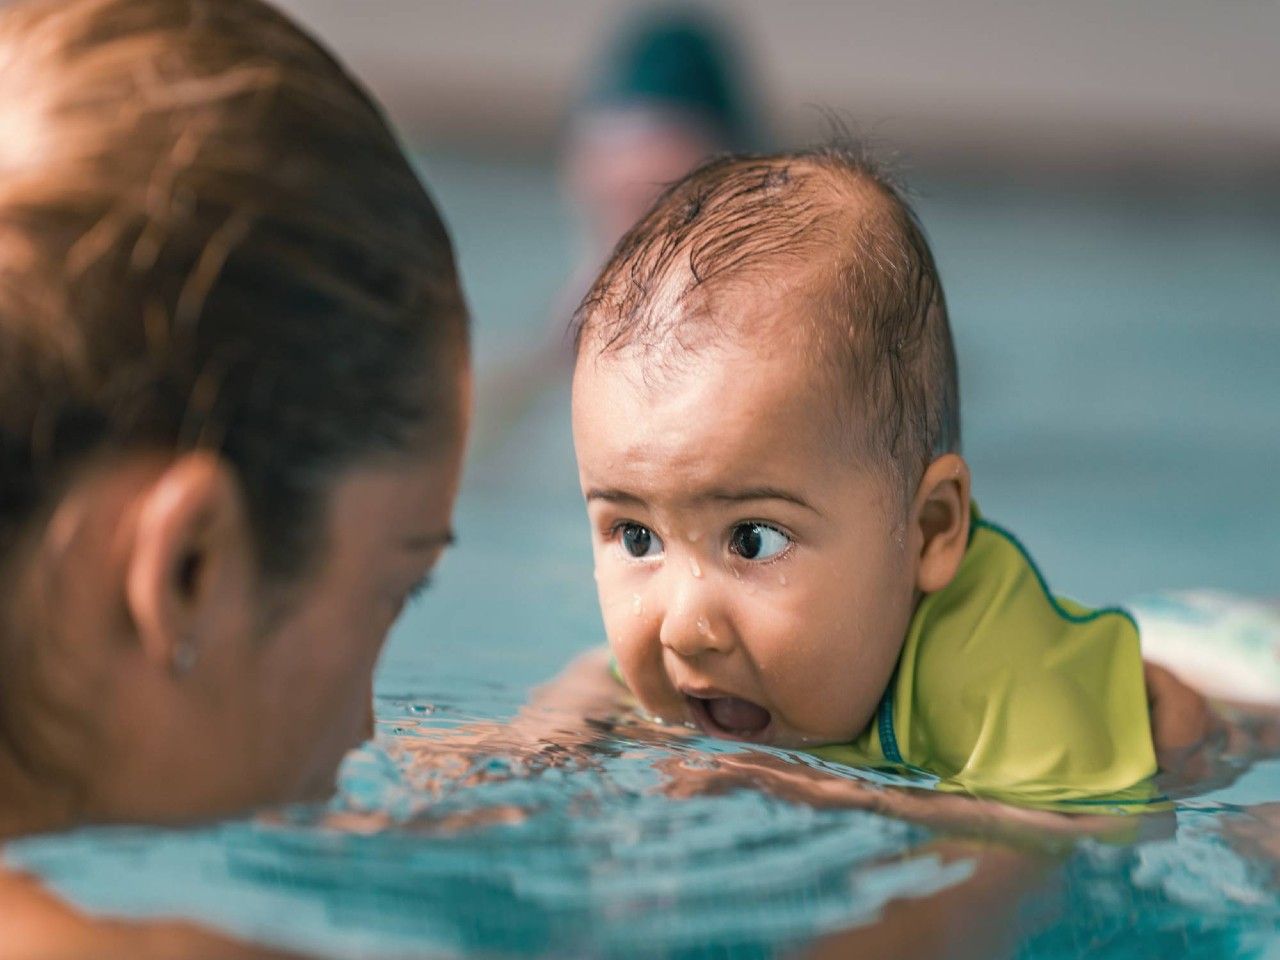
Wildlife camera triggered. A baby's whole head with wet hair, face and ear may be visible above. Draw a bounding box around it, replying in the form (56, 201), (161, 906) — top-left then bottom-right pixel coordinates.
(573, 147), (969, 746)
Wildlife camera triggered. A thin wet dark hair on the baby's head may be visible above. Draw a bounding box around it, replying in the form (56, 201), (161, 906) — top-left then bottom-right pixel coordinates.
(575, 142), (960, 483)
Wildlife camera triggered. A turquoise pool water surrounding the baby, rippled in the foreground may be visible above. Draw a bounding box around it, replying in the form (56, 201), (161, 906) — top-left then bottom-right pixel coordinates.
(6, 157), (1280, 957)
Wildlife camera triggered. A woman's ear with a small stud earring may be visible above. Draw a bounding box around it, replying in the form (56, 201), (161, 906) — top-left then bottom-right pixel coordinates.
(124, 452), (255, 676)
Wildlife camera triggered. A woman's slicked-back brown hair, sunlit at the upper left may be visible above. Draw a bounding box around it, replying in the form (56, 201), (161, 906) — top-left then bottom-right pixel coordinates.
(0, 0), (466, 576)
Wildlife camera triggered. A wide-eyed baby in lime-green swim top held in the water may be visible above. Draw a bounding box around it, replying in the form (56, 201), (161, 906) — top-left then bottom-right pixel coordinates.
(573, 140), (1207, 803)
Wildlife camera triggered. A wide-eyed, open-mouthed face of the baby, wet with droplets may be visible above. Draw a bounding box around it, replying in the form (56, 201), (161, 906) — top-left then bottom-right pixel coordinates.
(573, 344), (918, 746)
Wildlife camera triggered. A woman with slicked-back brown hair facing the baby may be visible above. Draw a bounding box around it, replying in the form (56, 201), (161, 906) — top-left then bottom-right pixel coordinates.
(0, 0), (470, 956)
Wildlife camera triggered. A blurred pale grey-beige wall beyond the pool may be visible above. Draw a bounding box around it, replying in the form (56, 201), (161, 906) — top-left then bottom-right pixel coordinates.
(275, 0), (1280, 189)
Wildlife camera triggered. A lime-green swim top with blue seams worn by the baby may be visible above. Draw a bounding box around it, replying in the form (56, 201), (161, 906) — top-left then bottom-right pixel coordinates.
(810, 507), (1158, 805)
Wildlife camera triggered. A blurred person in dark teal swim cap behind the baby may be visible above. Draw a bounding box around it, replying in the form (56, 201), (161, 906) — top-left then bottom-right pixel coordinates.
(477, 6), (765, 451)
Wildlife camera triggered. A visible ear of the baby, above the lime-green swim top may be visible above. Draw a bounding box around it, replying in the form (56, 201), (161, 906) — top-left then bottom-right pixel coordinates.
(911, 453), (970, 594)
